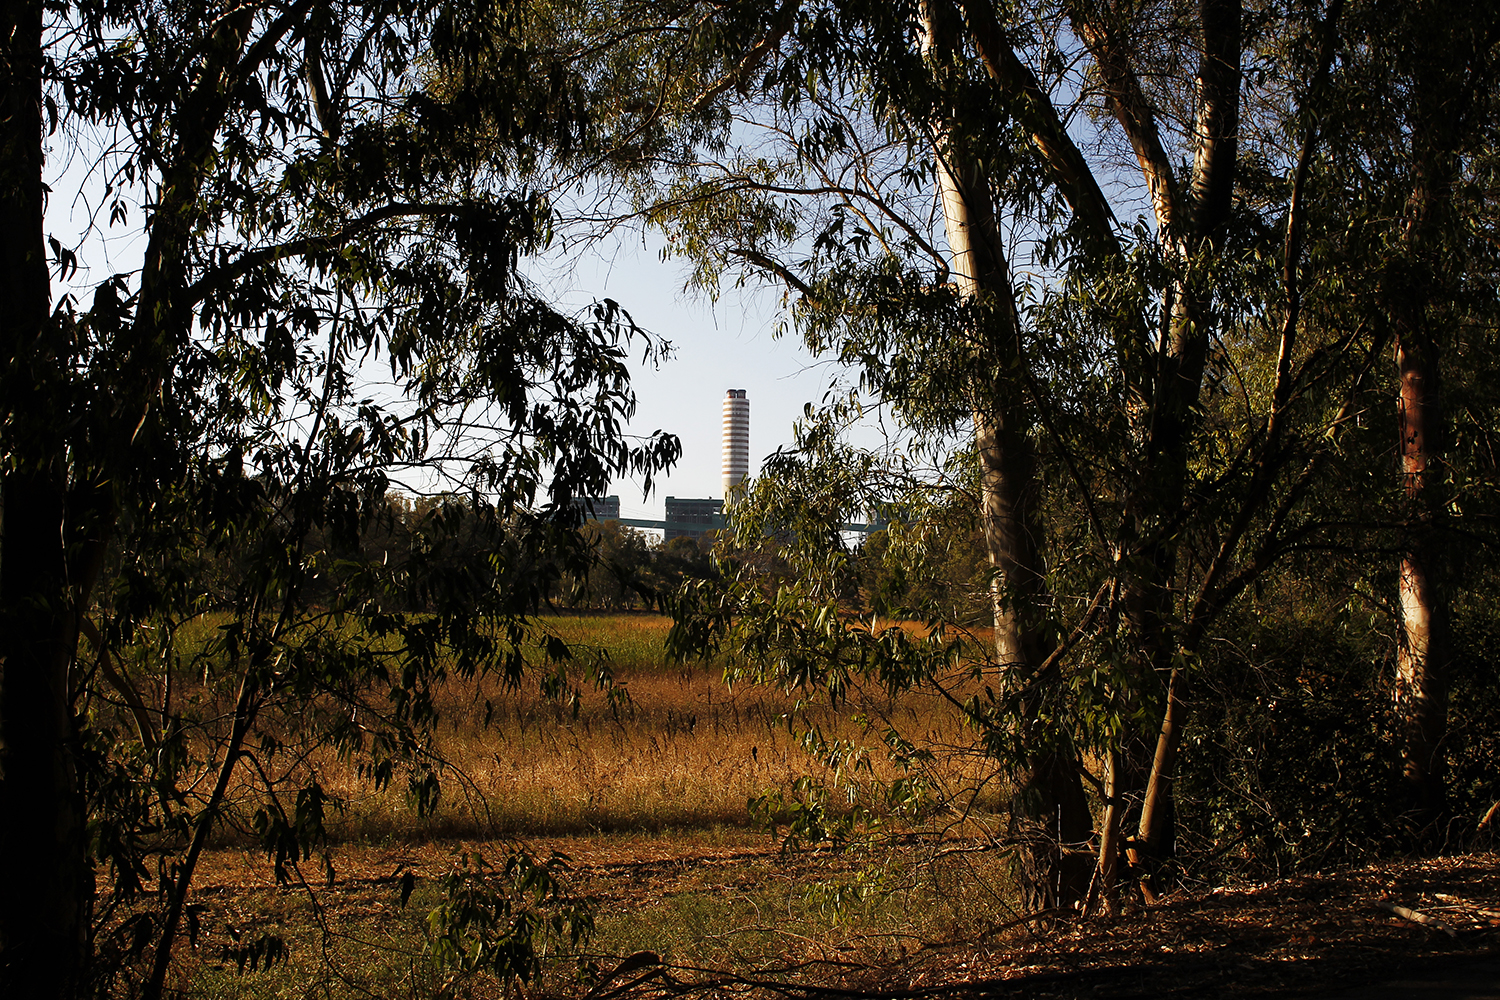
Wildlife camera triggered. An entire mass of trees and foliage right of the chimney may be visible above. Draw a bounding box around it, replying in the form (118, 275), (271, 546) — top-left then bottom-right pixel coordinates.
(654, 1), (1500, 906)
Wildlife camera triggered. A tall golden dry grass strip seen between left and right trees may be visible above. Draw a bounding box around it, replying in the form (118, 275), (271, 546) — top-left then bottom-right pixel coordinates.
(135, 613), (1007, 846)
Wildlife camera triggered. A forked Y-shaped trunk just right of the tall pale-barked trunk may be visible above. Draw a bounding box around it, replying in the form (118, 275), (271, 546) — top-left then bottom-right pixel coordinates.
(1068, 0), (1242, 893)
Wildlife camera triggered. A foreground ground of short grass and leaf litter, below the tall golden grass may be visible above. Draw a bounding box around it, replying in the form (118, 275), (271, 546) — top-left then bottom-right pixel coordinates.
(197, 832), (1500, 1000)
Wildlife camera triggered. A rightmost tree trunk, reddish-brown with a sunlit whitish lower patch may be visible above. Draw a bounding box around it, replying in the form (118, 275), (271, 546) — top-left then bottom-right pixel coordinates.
(1382, 3), (1500, 827)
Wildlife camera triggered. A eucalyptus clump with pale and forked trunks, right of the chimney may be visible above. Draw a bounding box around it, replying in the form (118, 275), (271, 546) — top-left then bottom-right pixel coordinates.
(636, 1), (1392, 895)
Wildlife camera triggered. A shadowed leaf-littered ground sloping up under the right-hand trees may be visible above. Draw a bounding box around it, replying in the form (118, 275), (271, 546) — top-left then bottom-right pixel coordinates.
(870, 855), (1500, 999)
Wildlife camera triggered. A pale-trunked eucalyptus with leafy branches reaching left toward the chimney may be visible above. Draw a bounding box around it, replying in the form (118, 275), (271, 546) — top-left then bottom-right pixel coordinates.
(633, 4), (1116, 897)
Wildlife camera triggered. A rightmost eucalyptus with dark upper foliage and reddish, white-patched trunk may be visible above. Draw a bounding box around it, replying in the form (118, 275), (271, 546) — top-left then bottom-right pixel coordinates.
(1326, 3), (1500, 844)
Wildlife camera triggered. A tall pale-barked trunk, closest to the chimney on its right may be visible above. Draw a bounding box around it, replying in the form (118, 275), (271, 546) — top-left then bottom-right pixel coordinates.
(923, 3), (1094, 906)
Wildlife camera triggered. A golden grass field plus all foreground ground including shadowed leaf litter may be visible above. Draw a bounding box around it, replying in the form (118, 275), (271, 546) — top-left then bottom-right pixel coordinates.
(155, 615), (1500, 1000)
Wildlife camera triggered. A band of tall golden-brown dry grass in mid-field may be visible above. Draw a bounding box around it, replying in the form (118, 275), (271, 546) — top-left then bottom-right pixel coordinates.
(317, 615), (983, 838)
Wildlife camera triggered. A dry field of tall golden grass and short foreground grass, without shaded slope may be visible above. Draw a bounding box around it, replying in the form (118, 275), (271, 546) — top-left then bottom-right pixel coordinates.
(167, 615), (1014, 999)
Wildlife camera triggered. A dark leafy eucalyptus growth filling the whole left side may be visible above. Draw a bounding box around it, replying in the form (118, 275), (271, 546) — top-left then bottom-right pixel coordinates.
(0, 0), (677, 997)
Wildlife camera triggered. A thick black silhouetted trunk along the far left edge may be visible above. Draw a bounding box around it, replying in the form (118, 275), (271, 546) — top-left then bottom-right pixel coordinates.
(0, 0), (93, 999)
